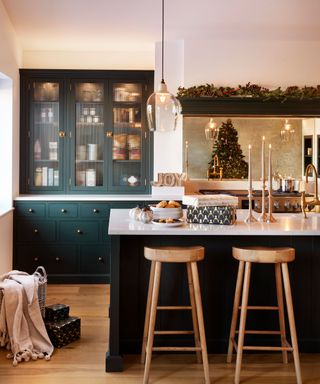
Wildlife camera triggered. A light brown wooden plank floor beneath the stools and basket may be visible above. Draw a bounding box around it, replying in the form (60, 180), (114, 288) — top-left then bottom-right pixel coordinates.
(0, 285), (320, 384)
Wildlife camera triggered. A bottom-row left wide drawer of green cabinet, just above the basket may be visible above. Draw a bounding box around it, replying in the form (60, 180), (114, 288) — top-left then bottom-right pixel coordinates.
(14, 245), (78, 274)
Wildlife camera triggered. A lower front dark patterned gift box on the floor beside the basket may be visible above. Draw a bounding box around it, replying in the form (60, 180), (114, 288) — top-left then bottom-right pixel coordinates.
(45, 317), (80, 348)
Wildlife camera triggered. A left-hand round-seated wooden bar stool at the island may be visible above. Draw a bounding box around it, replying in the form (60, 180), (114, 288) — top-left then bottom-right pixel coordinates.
(141, 246), (210, 384)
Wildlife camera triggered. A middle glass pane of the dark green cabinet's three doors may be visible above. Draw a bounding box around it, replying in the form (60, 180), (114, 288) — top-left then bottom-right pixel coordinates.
(71, 82), (107, 191)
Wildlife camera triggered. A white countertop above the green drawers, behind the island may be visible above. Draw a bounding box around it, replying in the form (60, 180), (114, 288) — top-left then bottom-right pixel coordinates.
(14, 194), (182, 201)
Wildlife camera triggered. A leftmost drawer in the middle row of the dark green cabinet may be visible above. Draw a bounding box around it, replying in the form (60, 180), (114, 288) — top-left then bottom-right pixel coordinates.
(17, 220), (56, 242)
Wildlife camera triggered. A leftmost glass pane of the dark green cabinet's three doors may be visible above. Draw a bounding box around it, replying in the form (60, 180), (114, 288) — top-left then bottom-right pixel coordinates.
(28, 81), (65, 191)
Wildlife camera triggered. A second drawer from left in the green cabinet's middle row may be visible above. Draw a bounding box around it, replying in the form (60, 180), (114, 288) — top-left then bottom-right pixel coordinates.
(60, 221), (99, 242)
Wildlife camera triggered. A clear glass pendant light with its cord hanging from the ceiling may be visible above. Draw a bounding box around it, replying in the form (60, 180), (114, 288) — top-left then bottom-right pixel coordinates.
(147, 0), (181, 132)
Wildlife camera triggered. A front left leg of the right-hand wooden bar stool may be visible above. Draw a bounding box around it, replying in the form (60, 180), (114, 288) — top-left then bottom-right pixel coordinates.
(234, 262), (251, 384)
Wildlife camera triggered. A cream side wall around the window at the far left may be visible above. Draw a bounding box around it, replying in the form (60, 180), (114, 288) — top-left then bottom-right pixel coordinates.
(0, 0), (21, 274)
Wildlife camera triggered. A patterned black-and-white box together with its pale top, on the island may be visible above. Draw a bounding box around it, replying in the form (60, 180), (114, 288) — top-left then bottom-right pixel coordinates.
(183, 194), (238, 225)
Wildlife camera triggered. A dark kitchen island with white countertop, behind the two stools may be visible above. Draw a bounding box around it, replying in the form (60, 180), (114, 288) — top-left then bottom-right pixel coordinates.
(106, 209), (320, 371)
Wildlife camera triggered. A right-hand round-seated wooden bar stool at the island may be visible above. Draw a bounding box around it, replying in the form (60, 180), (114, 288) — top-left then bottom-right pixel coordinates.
(227, 247), (302, 384)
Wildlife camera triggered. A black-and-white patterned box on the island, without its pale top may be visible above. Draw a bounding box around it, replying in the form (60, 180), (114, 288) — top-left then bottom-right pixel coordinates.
(187, 205), (236, 225)
